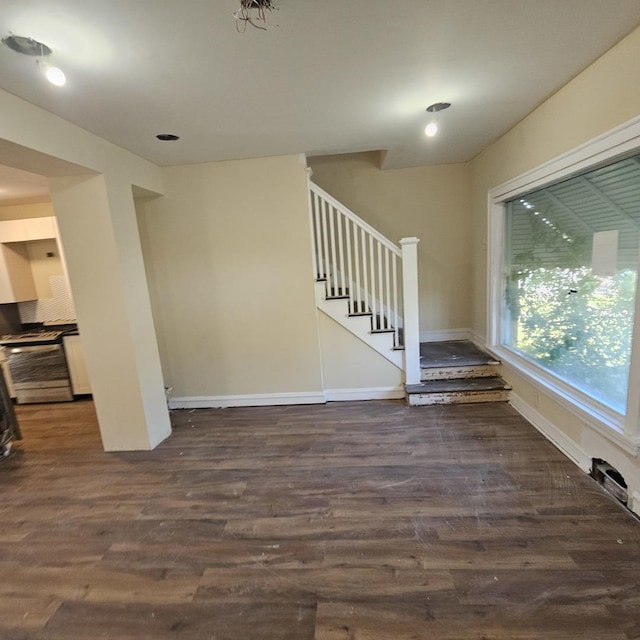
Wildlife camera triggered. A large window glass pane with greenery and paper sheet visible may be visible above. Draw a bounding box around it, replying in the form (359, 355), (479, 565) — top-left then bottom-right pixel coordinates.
(500, 156), (640, 414)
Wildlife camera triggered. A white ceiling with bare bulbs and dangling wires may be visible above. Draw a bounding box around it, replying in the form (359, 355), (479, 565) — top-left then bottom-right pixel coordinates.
(0, 0), (640, 197)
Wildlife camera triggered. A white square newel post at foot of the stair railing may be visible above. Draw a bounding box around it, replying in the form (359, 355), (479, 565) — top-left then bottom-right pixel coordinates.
(400, 238), (420, 384)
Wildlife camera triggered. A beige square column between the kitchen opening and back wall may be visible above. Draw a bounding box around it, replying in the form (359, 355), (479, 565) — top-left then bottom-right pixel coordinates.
(50, 170), (171, 451)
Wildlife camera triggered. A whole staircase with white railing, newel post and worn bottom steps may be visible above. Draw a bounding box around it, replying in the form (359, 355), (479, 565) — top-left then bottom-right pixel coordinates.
(309, 182), (510, 405)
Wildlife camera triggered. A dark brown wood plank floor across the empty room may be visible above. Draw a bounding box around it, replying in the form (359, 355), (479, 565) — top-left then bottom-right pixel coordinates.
(0, 401), (640, 640)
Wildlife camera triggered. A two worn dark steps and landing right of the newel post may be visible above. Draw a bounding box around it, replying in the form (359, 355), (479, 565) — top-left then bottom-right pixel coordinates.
(405, 340), (511, 406)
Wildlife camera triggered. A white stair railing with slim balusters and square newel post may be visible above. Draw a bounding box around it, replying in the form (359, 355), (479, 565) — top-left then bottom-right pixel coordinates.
(309, 182), (420, 384)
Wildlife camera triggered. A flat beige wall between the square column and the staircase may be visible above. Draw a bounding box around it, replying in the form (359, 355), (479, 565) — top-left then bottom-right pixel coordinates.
(138, 156), (322, 398)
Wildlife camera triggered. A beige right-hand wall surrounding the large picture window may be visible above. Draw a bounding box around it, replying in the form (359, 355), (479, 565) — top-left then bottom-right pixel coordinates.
(471, 30), (640, 500)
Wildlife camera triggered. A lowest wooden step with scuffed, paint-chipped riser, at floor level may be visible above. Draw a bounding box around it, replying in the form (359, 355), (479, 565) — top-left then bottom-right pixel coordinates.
(405, 377), (511, 406)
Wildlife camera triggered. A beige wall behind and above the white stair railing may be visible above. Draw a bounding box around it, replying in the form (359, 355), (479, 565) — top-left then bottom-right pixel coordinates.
(309, 152), (473, 334)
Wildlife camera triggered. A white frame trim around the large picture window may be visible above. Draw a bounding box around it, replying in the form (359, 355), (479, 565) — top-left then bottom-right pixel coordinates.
(487, 116), (640, 456)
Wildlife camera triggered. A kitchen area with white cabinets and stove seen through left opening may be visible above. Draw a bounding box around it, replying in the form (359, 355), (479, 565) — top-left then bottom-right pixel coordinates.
(0, 210), (91, 420)
